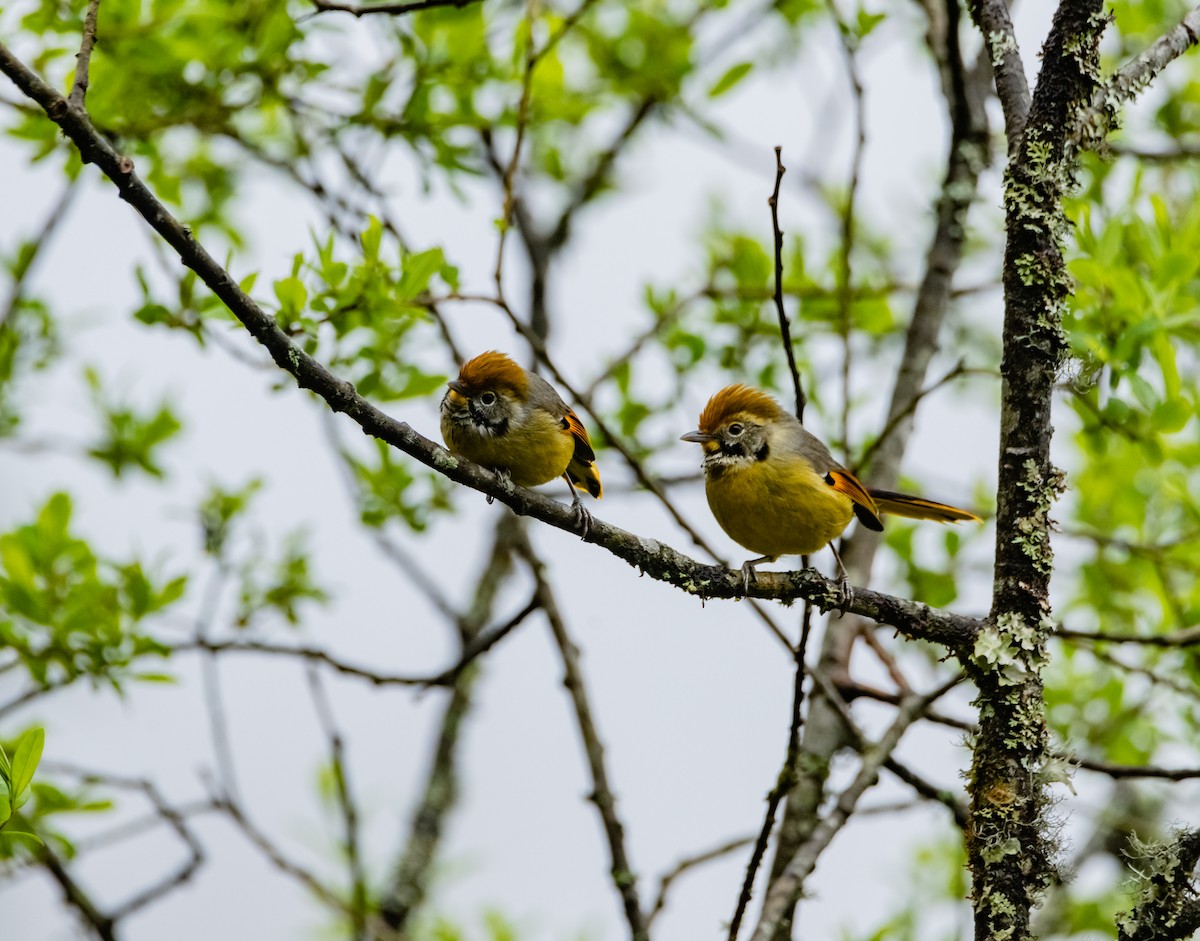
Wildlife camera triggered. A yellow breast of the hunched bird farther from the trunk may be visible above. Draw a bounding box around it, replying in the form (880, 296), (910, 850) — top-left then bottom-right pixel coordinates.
(442, 409), (575, 487)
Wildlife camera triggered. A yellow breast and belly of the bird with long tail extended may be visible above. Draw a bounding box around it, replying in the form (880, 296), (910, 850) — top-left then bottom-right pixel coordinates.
(704, 456), (853, 558)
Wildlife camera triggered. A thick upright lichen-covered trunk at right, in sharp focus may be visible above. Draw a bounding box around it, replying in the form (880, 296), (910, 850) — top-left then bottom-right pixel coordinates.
(967, 0), (1105, 941)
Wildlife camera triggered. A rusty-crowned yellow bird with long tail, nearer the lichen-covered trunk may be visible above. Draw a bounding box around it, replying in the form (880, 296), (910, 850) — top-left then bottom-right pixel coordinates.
(682, 384), (979, 602)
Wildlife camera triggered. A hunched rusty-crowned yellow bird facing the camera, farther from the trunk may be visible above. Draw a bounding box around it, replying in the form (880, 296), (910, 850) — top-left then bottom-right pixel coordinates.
(440, 349), (604, 538)
